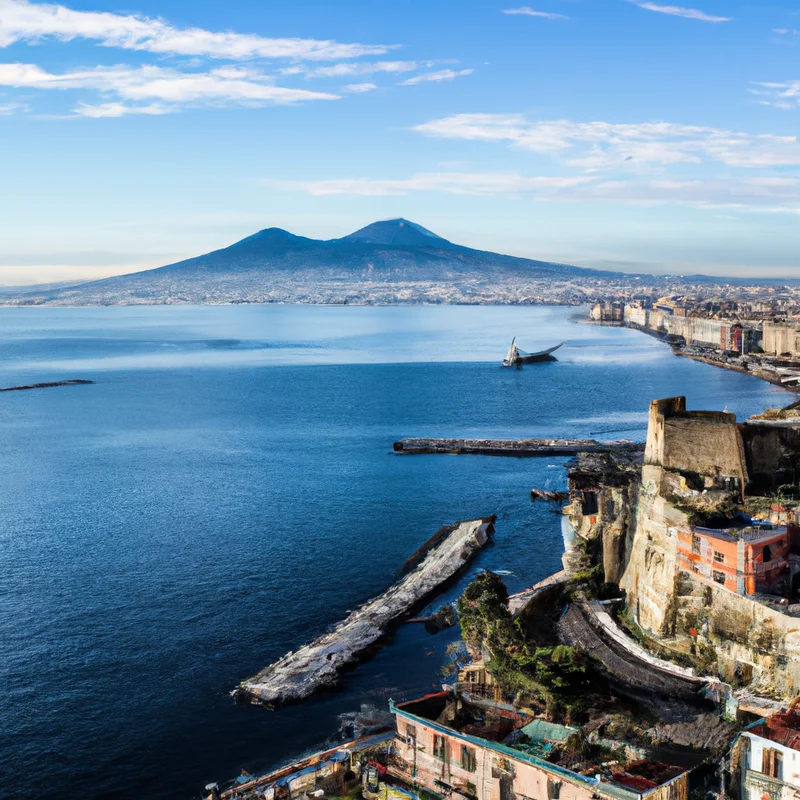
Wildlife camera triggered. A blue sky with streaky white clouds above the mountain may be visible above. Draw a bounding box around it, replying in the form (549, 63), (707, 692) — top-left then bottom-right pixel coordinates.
(0, 0), (800, 285)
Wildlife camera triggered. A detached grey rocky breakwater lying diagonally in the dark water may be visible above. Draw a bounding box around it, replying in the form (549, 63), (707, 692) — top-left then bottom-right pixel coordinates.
(233, 517), (495, 709)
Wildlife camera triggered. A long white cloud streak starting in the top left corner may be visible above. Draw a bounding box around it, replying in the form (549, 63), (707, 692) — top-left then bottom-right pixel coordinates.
(0, 0), (395, 61)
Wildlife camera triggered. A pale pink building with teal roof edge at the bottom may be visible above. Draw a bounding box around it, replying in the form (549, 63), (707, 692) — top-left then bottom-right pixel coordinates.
(389, 692), (688, 800)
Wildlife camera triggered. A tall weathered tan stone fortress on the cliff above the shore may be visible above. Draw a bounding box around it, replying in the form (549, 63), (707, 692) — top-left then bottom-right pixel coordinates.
(564, 397), (800, 697)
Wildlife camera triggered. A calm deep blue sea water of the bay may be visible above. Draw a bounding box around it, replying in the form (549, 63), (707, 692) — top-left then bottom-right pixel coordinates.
(0, 307), (787, 798)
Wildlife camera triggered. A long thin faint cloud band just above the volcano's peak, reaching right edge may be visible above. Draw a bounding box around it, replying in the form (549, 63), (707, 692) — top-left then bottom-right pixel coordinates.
(264, 172), (800, 214)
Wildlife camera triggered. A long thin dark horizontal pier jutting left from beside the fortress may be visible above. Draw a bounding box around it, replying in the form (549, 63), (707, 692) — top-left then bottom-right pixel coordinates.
(393, 438), (644, 458)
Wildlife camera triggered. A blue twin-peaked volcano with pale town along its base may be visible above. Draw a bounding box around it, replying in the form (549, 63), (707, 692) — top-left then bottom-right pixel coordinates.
(9, 219), (628, 305)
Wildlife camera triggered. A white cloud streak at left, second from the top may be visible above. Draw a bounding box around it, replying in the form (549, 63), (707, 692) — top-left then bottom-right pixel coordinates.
(0, 64), (337, 116)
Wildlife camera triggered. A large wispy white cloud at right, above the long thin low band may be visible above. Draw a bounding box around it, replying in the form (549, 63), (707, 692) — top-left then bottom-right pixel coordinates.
(414, 114), (800, 171)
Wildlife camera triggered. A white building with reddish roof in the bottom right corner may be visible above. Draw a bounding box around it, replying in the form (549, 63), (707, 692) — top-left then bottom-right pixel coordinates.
(733, 713), (800, 800)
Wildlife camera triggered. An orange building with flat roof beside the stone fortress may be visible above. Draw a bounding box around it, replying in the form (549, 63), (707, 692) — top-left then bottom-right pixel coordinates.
(677, 526), (790, 594)
